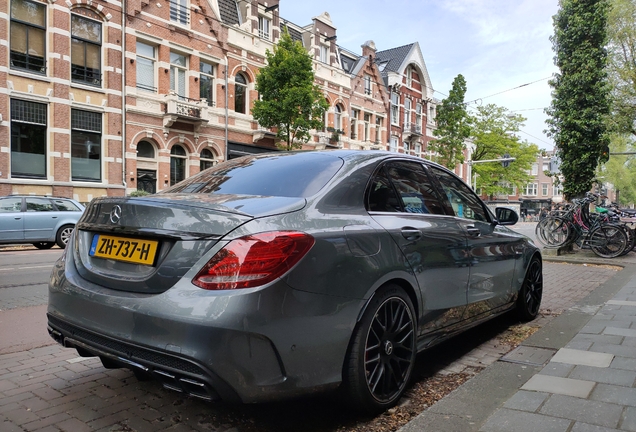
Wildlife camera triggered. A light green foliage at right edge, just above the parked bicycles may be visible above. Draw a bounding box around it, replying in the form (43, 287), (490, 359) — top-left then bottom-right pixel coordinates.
(598, 134), (636, 206)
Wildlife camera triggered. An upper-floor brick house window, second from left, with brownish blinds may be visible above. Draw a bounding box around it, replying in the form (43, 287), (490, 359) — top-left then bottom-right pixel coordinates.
(71, 14), (102, 86)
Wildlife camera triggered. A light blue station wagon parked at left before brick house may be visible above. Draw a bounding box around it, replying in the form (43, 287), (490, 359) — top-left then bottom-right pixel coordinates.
(0, 195), (84, 249)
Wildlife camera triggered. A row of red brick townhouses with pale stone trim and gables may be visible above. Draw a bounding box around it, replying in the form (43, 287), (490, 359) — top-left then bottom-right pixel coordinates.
(0, 0), (436, 202)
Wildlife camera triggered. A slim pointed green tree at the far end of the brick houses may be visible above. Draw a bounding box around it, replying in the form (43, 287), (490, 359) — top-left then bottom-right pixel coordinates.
(429, 74), (470, 169)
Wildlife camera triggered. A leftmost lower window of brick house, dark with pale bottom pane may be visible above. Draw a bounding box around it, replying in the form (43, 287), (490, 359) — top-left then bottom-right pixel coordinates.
(11, 99), (47, 179)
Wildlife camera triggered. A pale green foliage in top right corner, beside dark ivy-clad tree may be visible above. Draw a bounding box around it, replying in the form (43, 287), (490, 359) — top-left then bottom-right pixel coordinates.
(607, 0), (636, 135)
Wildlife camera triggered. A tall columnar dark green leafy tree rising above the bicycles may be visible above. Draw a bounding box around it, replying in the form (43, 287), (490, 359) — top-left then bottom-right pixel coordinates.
(546, 0), (610, 198)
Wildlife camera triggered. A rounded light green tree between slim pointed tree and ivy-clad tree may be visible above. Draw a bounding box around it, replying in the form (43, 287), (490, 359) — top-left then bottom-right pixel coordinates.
(472, 104), (539, 196)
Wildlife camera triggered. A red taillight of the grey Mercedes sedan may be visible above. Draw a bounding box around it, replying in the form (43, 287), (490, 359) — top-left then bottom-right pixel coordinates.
(192, 231), (314, 290)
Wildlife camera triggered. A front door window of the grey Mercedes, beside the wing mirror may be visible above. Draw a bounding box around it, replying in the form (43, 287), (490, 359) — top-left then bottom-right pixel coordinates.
(430, 167), (490, 222)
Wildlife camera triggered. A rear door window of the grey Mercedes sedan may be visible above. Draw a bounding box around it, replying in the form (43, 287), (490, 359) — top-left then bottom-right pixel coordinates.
(387, 162), (445, 214)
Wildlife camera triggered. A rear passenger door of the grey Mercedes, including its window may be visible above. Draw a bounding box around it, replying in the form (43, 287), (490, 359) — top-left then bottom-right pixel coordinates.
(367, 160), (469, 334)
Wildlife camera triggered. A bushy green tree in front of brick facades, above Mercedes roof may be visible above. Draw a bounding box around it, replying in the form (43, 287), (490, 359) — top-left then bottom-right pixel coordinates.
(252, 30), (329, 150)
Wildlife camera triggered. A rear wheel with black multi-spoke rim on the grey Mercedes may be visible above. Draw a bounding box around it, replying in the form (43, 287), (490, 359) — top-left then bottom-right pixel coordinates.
(343, 285), (417, 414)
